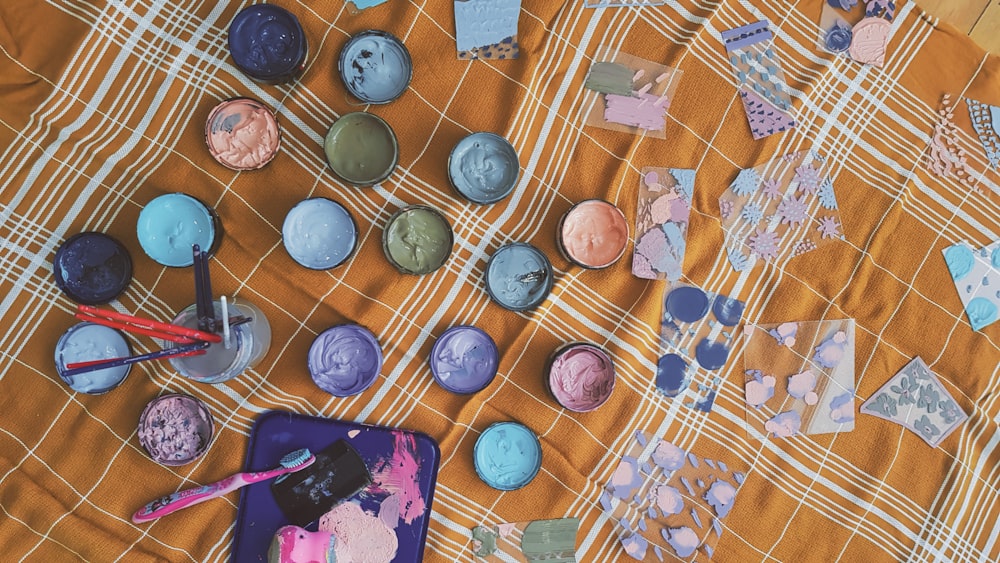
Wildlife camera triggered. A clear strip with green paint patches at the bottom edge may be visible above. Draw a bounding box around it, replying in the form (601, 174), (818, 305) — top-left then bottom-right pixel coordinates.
(472, 518), (580, 563)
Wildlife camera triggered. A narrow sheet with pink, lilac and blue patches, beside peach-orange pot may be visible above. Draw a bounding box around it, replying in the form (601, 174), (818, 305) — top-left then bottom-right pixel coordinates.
(632, 167), (695, 281)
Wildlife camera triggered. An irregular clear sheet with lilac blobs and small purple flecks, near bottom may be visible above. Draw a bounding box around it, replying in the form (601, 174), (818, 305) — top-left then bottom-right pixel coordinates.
(600, 431), (745, 561)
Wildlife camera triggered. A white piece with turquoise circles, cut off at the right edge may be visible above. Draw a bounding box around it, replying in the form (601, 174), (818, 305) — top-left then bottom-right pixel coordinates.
(943, 240), (1000, 330)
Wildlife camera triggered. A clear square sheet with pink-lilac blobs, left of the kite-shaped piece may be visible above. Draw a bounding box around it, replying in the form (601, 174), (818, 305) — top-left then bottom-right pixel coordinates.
(743, 319), (855, 438)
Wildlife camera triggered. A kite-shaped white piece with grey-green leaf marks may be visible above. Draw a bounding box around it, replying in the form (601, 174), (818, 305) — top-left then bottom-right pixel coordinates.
(861, 356), (969, 448)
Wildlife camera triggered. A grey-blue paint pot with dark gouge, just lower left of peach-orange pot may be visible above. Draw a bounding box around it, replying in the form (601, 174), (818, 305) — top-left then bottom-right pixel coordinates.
(486, 242), (554, 311)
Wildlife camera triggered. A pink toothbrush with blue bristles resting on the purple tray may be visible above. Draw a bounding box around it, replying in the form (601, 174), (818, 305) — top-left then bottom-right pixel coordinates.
(132, 448), (316, 524)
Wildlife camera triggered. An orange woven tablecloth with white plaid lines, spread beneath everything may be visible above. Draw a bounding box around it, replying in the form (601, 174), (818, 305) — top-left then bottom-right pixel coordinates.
(0, 0), (1000, 562)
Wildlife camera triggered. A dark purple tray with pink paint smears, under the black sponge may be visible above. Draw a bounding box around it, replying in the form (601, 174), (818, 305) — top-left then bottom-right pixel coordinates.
(230, 411), (441, 563)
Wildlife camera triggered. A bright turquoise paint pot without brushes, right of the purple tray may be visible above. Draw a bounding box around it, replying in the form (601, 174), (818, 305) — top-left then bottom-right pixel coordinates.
(472, 422), (542, 491)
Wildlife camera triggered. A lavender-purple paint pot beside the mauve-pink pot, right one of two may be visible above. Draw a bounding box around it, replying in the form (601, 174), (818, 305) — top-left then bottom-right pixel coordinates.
(430, 325), (500, 395)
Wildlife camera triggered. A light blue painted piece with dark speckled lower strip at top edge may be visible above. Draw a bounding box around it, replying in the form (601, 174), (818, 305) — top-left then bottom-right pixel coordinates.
(455, 0), (521, 59)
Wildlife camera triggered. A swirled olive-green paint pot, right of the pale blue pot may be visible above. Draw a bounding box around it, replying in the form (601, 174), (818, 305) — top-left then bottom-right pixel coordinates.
(382, 205), (454, 276)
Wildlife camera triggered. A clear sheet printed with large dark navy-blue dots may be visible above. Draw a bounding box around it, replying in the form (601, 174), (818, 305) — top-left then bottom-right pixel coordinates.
(655, 282), (745, 412)
